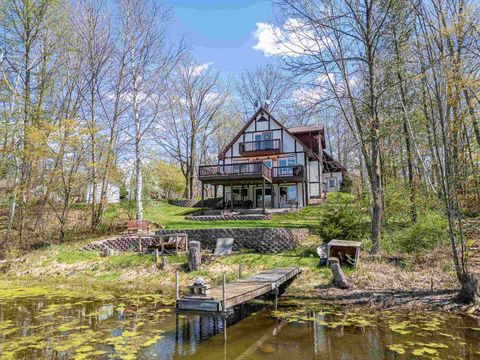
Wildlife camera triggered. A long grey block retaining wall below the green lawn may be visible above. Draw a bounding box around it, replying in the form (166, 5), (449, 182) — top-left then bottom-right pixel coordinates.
(83, 228), (309, 253)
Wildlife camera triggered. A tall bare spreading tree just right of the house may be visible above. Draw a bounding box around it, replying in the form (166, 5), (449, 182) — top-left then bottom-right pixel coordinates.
(278, 0), (391, 253)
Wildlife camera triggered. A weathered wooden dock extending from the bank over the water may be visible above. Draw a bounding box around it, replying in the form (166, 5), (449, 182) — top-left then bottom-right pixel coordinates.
(177, 268), (301, 312)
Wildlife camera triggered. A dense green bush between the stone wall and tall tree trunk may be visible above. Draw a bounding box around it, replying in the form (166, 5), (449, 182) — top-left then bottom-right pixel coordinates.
(319, 193), (368, 242)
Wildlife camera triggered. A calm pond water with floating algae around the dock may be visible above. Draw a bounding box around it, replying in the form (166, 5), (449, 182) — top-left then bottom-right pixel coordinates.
(0, 288), (480, 360)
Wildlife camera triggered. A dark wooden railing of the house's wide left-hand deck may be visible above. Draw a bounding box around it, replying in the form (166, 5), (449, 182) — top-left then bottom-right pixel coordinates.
(198, 162), (272, 180)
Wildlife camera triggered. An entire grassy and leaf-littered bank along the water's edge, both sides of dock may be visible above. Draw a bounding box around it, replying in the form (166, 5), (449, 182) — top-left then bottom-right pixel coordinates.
(0, 243), (480, 325)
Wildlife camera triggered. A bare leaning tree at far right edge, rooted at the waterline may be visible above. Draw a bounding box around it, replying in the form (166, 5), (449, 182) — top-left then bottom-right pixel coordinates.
(415, 0), (480, 302)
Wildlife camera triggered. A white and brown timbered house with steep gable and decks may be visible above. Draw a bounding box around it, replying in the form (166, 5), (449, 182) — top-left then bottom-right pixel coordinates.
(198, 108), (346, 210)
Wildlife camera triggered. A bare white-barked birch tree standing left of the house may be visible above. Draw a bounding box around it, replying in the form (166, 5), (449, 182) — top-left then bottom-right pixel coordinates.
(121, 0), (183, 221)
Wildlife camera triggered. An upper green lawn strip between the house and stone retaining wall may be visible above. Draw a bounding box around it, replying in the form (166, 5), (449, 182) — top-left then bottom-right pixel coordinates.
(145, 201), (322, 230)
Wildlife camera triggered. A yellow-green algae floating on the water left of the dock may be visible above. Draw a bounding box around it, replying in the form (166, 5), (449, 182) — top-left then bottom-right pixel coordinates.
(0, 287), (171, 359)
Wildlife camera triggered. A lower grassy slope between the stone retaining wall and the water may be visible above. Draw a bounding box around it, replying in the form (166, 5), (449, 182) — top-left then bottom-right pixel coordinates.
(0, 237), (330, 295)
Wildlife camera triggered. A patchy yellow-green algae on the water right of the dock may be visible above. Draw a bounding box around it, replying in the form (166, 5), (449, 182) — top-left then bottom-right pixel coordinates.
(271, 303), (480, 359)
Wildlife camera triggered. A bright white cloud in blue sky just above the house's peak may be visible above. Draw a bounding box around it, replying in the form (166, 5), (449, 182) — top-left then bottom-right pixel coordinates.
(253, 18), (329, 57)
